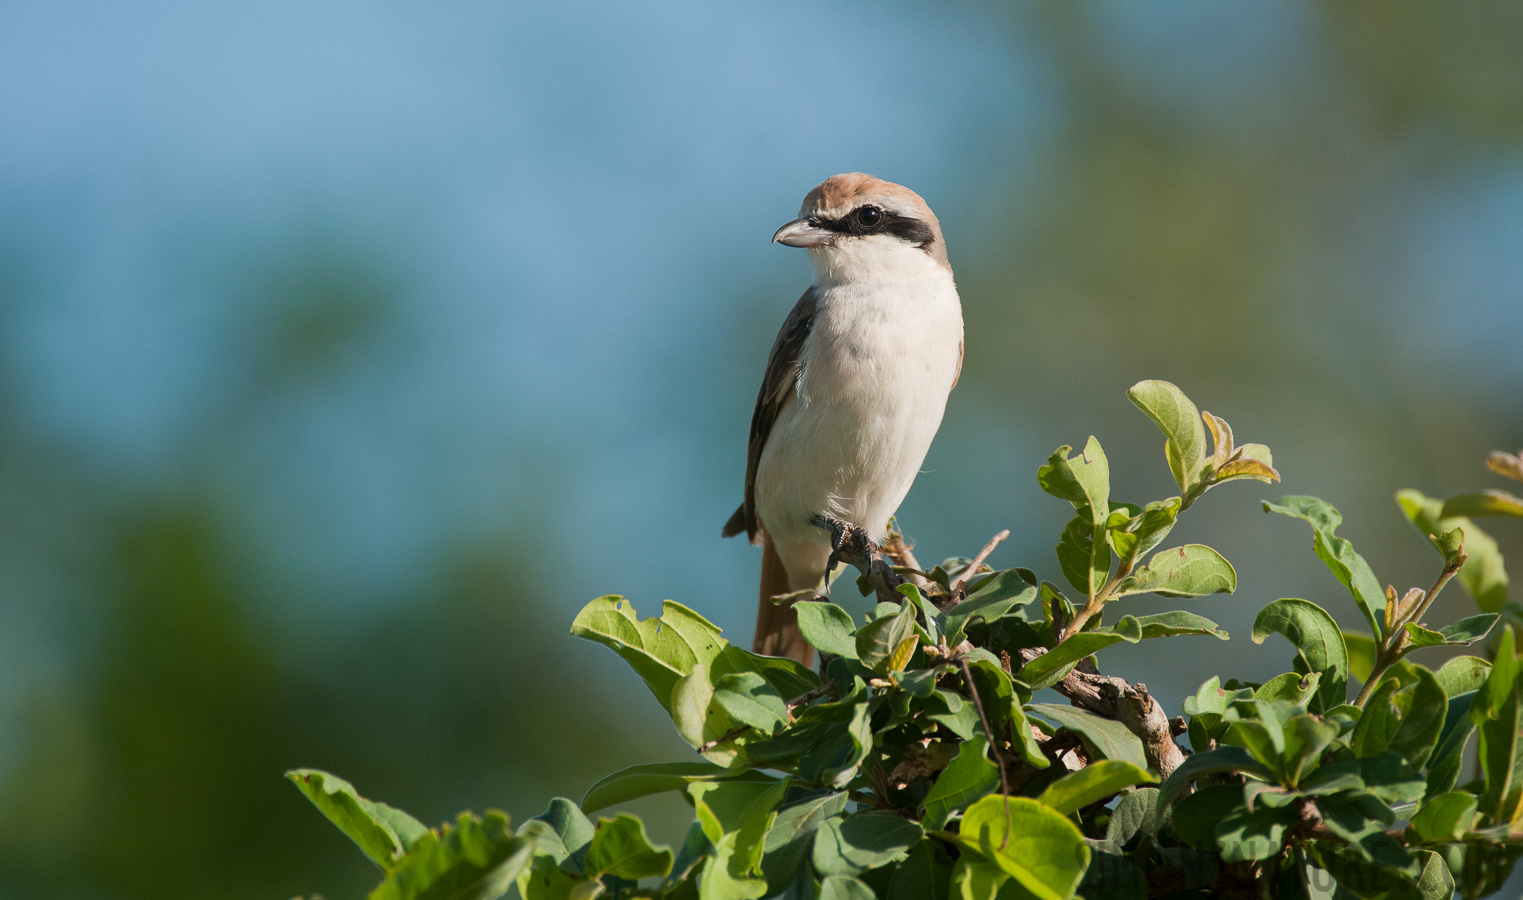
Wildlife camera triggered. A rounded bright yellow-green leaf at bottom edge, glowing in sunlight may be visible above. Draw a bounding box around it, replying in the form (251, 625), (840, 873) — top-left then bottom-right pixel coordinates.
(958, 795), (1089, 900)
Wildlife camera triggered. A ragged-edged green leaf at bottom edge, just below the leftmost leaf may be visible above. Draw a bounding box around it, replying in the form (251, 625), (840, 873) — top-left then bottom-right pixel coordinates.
(370, 810), (535, 900)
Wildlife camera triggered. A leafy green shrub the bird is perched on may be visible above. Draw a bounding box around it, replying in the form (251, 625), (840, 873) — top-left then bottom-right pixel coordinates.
(289, 381), (1523, 900)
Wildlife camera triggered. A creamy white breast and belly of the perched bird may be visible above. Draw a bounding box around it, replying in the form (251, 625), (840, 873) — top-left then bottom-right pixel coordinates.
(755, 248), (963, 589)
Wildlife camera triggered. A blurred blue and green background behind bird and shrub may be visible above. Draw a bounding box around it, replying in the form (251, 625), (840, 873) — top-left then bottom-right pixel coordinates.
(0, 0), (1523, 900)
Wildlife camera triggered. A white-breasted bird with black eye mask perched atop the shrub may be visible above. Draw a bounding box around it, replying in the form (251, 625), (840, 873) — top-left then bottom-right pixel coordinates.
(722, 172), (963, 667)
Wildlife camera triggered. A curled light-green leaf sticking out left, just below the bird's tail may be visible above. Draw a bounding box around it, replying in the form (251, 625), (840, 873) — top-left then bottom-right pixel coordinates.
(571, 594), (726, 711)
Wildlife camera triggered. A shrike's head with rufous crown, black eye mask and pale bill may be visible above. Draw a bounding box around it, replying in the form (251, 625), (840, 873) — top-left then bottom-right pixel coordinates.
(772, 172), (952, 280)
